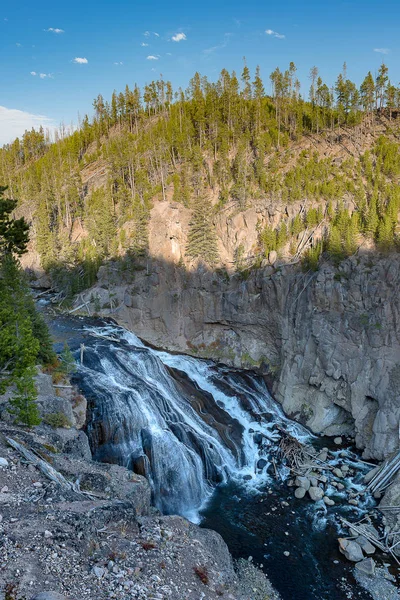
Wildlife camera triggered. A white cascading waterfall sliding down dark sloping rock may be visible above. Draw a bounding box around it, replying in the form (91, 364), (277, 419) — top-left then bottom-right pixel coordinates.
(80, 325), (310, 520)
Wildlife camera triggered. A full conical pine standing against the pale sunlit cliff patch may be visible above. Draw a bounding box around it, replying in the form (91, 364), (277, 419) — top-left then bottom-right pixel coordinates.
(186, 195), (219, 267)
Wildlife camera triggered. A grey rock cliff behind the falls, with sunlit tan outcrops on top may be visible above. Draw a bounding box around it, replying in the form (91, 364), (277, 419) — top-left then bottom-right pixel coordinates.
(72, 203), (400, 459)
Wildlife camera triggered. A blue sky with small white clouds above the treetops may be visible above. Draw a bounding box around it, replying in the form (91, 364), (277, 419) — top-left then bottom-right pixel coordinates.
(0, 0), (400, 144)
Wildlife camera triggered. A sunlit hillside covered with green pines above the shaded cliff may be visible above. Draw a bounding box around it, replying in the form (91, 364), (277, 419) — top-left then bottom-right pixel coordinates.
(0, 63), (400, 300)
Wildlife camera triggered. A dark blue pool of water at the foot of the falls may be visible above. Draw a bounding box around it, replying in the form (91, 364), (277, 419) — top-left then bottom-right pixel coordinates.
(202, 482), (371, 600)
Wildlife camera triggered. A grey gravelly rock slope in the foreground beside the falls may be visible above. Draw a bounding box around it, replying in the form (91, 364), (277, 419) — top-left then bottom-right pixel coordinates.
(0, 373), (278, 600)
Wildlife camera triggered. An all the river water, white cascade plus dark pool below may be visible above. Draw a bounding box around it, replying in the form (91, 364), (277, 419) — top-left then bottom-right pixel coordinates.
(43, 316), (384, 600)
